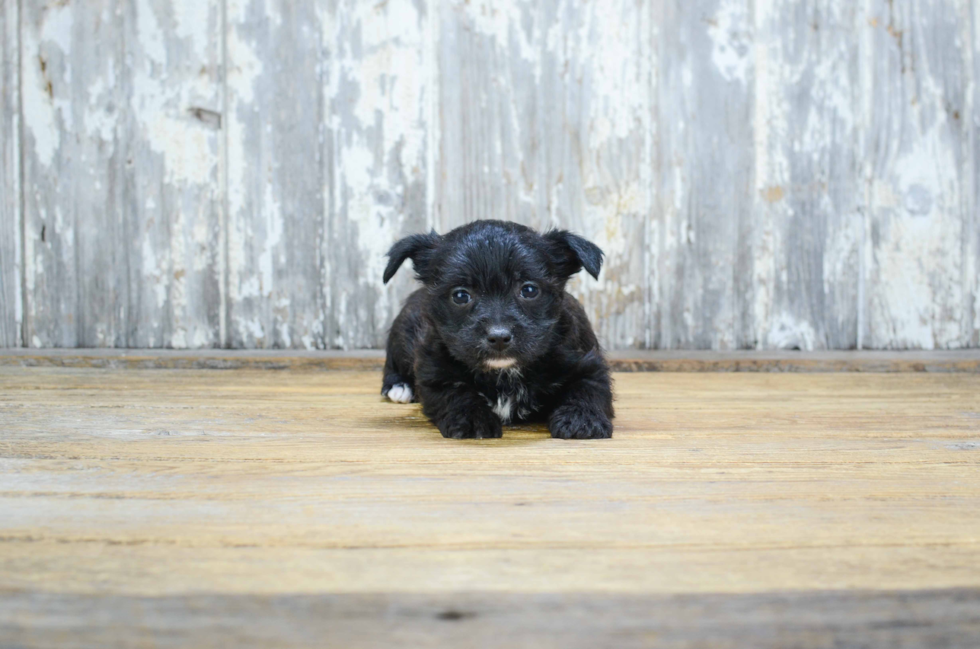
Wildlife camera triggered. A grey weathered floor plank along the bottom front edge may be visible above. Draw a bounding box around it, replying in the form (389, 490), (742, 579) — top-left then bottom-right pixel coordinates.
(0, 590), (980, 649)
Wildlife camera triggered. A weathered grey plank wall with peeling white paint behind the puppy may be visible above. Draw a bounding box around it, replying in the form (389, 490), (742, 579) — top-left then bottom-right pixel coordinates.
(0, 0), (980, 349)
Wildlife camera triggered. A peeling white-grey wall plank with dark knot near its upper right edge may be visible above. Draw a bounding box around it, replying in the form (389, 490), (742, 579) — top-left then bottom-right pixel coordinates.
(125, 0), (222, 348)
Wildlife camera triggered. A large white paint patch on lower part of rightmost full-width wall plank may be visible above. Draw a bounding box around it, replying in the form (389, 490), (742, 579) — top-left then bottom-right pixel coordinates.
(868, 12), (972, 349)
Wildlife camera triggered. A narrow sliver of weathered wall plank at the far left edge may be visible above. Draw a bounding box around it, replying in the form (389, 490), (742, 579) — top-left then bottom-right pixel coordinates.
(0, 2), (24, 347)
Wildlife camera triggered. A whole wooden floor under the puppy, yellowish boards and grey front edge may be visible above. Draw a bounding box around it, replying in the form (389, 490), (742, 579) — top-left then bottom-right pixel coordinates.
(0, 366), (980, 649)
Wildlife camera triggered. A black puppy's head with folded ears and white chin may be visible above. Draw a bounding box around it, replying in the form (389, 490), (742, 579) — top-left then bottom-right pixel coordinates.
(384, 221), (602, 372)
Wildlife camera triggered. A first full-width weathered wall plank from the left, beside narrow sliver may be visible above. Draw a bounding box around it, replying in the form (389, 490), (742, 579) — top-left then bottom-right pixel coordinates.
(21, 0), (121, 347)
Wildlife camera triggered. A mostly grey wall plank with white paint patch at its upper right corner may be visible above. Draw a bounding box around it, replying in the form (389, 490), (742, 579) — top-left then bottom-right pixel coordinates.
(651, 0), (760, 349)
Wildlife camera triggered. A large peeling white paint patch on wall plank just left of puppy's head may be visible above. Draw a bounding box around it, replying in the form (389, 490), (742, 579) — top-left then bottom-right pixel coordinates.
(324, 0), (434, 347)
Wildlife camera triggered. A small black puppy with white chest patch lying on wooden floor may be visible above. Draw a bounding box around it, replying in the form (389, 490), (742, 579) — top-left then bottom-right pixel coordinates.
(381, 221), (613, 439)
